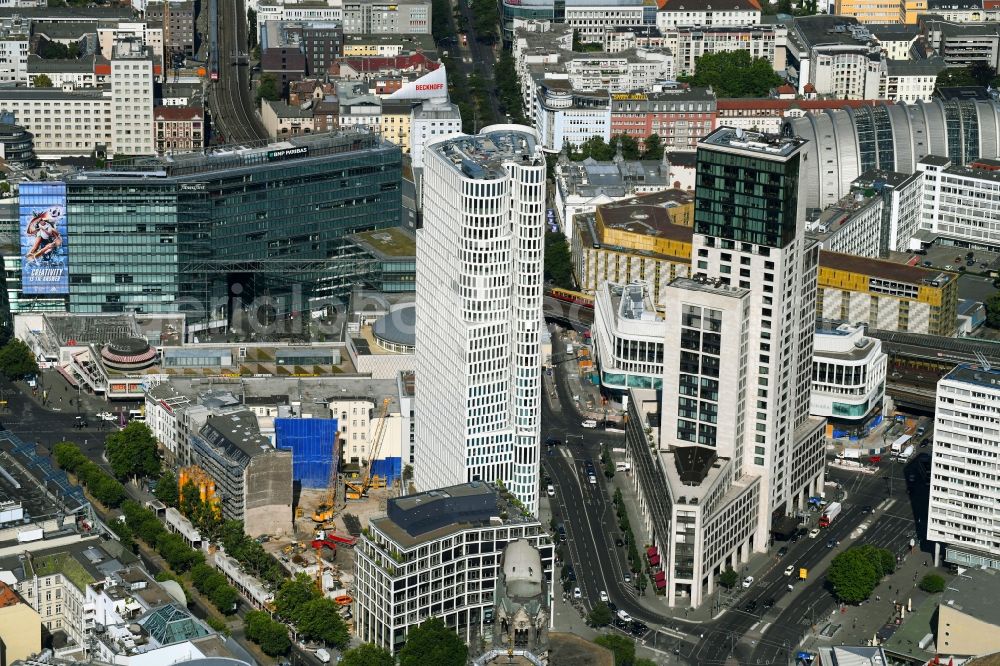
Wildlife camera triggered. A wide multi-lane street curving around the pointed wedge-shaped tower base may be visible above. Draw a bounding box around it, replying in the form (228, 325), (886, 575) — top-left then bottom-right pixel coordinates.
(542, 324), (929, 664)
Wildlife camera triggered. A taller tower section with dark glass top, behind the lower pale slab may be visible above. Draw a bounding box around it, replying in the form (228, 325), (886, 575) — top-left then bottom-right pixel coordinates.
(685, 128), (824, 550)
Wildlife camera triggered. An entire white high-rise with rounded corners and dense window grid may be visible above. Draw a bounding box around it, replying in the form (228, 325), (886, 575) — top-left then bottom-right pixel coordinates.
(414, 125), (545, 514)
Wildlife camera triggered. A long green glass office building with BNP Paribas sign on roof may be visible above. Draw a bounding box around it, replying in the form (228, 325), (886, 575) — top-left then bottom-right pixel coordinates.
(58, 130), (402, 320)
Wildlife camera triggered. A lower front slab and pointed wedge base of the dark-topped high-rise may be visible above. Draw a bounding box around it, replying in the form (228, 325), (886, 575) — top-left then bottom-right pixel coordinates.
(626, 278), (761, 606)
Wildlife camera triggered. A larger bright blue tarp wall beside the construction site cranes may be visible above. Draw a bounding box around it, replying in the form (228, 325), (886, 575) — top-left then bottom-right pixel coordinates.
(274, 419), (337, 488)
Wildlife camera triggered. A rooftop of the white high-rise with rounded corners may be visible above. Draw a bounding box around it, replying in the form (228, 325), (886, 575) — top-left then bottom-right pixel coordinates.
(429, 127), (540, 180)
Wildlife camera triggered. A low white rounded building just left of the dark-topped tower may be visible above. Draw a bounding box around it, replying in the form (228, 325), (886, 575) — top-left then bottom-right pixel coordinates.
(591, 282), (667, 392)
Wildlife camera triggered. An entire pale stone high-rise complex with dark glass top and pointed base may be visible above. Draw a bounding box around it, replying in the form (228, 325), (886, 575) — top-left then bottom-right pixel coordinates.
(626, 128), (825, 605)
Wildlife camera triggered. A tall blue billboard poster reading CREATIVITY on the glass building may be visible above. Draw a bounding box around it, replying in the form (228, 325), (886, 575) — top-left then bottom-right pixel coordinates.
(18, 183), (69, 294)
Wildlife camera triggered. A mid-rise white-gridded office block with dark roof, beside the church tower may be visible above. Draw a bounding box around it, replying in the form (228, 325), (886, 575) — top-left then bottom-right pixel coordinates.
(354, 480), (553, 652)
